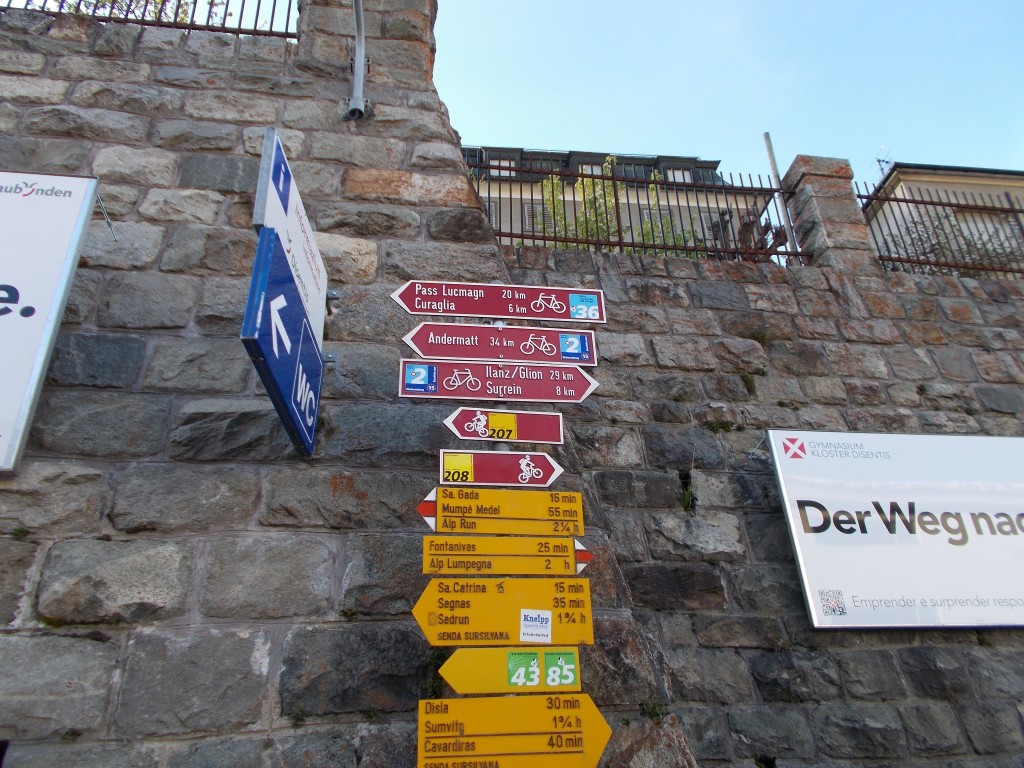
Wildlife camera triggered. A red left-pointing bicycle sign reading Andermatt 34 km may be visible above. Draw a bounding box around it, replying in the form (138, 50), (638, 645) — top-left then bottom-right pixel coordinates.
(402, 323), (597, 366)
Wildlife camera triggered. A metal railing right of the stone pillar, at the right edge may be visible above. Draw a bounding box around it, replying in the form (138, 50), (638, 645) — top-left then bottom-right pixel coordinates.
(855, 184), (1024, 280)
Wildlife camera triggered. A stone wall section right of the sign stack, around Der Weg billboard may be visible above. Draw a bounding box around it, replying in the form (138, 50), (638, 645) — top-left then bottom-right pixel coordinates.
(506, 244), (1024, 766)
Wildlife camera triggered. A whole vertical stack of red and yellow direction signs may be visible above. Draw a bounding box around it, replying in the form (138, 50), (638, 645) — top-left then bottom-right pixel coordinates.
(391, 281), (610, 768)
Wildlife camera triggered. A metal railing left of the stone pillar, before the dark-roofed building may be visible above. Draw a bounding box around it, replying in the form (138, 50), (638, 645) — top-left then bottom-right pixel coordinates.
(468, 159), (803, 264)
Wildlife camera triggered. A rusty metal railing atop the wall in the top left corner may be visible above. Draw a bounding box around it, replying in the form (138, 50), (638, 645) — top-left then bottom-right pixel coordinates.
(0, 0), (299, 39)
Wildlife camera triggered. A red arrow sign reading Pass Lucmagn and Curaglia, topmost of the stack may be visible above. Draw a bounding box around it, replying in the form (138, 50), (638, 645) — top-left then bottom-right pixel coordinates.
(391, 280), (607, 323)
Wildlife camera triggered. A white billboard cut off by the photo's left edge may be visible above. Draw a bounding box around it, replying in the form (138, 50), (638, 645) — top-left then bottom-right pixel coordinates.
(0, 171), (96, 471)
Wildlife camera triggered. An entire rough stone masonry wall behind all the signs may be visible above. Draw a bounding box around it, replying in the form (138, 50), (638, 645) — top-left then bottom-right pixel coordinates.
(0, 0), (1024, 768)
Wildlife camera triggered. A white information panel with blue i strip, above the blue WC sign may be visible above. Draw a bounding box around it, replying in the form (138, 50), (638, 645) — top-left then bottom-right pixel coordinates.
(253, 128), (327, 349)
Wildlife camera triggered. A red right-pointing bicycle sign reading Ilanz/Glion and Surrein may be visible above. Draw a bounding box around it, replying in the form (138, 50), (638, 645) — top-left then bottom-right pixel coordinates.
(398, 359), (597, 402)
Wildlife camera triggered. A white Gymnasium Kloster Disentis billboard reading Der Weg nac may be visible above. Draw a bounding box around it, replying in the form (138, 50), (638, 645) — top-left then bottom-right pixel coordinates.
(768, 430), (1024, 628)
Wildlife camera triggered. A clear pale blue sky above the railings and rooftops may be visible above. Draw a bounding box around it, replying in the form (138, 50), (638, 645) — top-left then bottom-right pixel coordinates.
(434, 0), (1024, 183)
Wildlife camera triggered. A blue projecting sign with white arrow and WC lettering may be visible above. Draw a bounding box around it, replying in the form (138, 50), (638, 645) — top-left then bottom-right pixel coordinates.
(242, 226), (324, 456)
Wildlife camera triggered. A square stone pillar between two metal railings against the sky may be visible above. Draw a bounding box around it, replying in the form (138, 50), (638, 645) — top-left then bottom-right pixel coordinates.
(782, 155), (882, 274)
